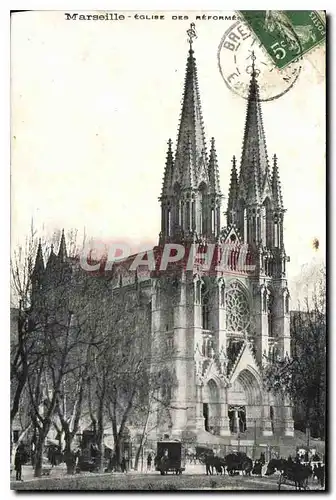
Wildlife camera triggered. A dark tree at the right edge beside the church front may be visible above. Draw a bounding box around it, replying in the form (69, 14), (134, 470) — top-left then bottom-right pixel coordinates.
(264, 268), (326, 438)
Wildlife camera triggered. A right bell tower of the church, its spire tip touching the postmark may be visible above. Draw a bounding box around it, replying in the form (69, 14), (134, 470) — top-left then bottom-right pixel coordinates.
(227, 53), (293, 435)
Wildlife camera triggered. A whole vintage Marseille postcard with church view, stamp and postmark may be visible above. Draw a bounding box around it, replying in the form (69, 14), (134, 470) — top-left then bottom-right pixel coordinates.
(10, 10), (328, 491)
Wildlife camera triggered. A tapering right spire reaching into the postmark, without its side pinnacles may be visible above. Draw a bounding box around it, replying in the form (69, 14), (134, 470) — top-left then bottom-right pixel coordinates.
(239, 52), (268, 198)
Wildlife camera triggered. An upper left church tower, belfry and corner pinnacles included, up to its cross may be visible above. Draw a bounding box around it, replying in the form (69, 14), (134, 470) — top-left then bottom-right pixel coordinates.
(160, 23), (221, 244)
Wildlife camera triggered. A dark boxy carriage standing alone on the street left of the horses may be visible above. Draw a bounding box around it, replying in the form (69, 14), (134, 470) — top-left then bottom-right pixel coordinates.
(155, 441), (185, 475)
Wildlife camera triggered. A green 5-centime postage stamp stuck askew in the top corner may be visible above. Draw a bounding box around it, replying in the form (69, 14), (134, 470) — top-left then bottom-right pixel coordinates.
(239, 10), (326, 69)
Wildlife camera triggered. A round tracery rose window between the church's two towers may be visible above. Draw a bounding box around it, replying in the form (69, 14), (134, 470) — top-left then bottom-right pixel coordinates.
(226, 283), (250, 332)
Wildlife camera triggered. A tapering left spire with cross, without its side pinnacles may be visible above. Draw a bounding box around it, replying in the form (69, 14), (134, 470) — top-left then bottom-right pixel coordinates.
(174, 23), (208, 188)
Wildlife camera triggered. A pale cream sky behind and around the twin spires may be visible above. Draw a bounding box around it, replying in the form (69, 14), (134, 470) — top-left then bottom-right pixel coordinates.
(11, 11), (326, 296)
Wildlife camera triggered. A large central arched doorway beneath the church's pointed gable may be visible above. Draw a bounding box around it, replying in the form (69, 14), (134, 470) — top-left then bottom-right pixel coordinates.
(228, 369), (262, 433)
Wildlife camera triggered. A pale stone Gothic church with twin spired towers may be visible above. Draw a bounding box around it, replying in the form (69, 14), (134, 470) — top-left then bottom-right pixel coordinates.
(33, 27), (294, 443)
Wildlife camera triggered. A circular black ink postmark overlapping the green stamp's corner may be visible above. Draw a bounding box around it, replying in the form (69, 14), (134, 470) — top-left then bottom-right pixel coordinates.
(217, 21), (301, 101)
